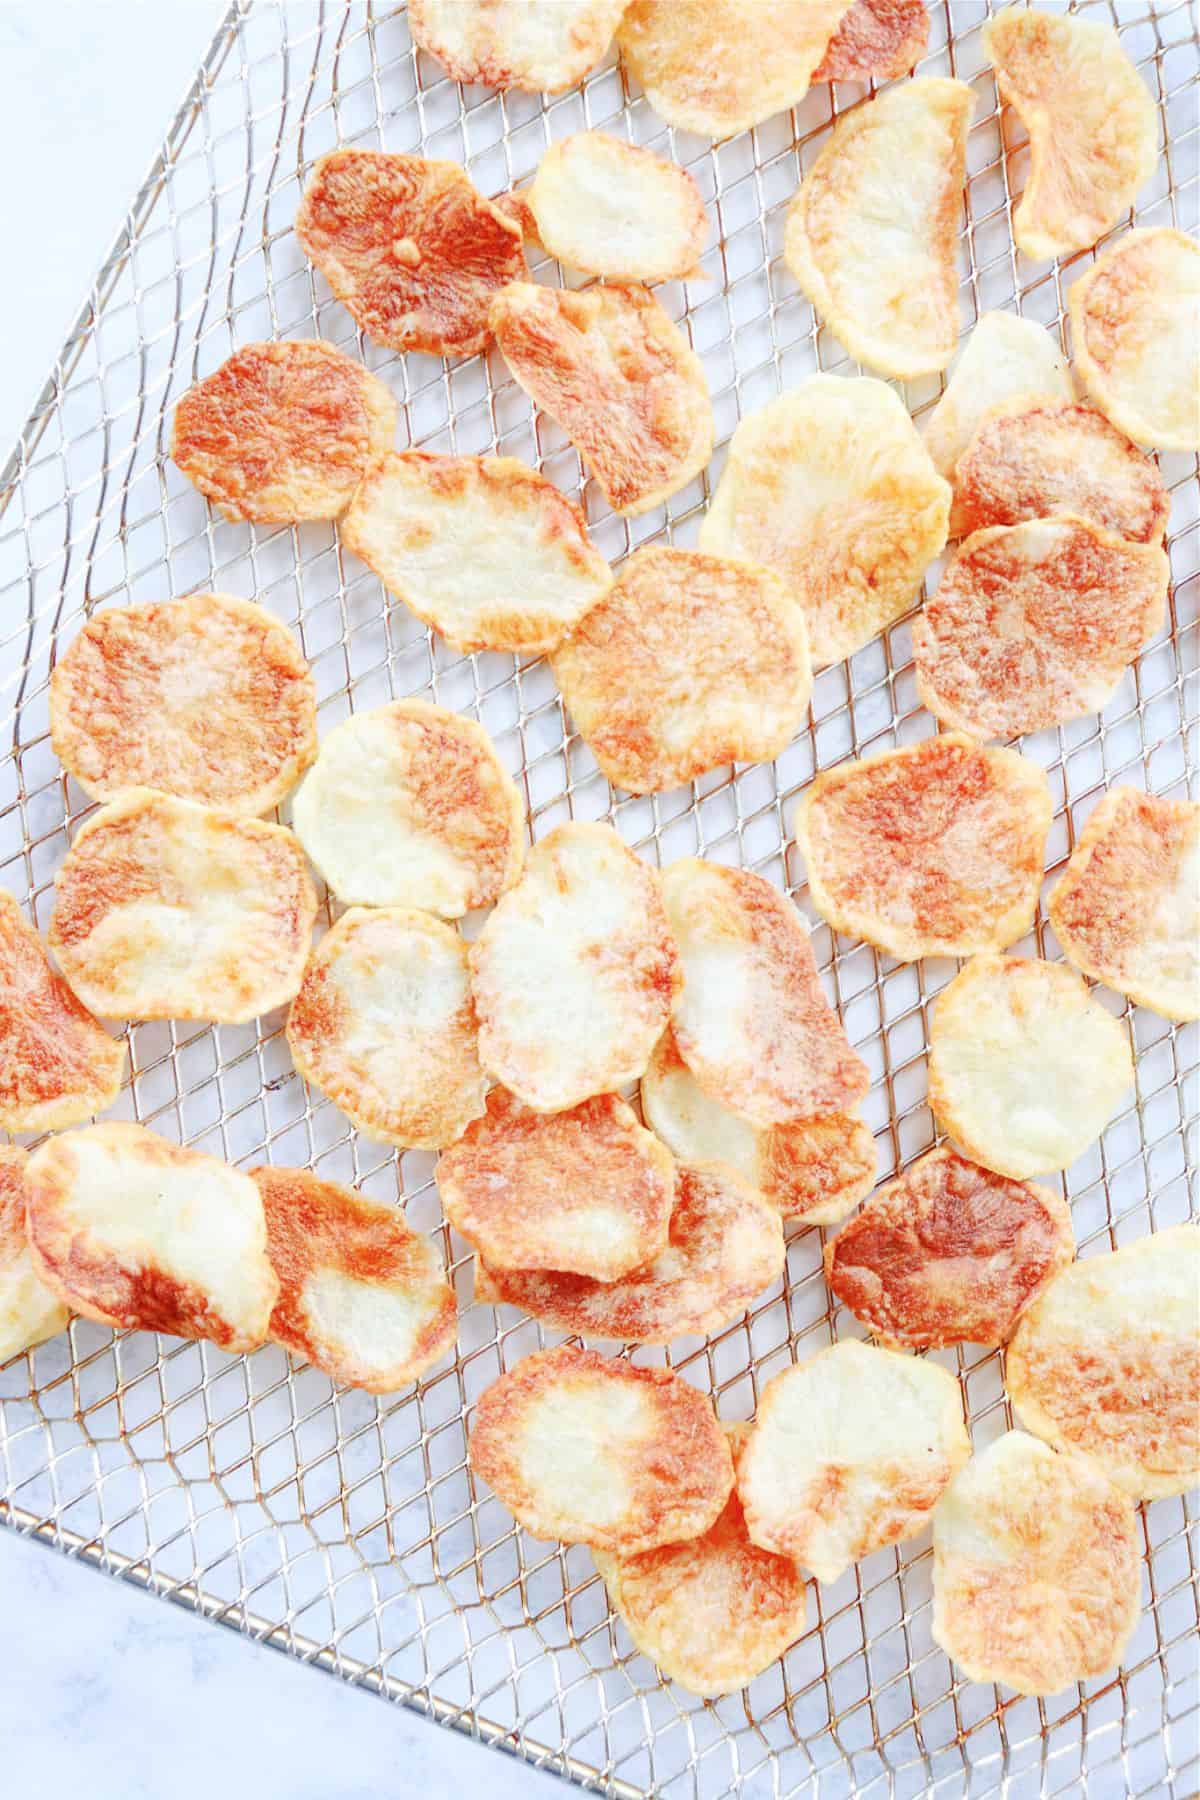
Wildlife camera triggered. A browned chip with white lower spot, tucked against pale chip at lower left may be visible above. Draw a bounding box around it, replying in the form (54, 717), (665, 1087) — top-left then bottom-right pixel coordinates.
(250, 1166), (459, 1393)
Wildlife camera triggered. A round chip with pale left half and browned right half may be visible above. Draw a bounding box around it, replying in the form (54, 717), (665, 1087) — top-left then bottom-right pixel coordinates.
(291, 700), (525, 918)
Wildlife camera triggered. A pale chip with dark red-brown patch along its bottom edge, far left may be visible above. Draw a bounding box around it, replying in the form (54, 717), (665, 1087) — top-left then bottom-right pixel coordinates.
(25, 1123), (279, 1354)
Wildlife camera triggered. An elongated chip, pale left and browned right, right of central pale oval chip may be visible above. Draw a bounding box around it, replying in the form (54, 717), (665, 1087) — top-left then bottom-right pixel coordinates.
(662, 857), (871, 1125)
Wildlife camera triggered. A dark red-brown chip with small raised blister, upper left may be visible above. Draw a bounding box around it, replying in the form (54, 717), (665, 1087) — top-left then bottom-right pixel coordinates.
(295, 149), (525, 358)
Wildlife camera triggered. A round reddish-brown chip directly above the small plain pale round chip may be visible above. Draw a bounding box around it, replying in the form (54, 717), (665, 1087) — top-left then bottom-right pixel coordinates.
(793, 731), (1052, 963)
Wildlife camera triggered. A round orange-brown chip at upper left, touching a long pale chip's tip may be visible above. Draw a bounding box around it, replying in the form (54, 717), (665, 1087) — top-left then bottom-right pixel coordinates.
(171, 340), (396, 526)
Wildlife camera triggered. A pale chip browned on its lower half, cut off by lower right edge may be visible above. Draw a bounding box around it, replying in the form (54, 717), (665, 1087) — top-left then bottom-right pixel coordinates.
(1007, 1224), (1200, 1499)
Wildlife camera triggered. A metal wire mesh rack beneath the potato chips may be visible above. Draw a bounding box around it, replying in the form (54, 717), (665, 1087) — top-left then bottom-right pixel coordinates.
(0, 0), (1200, 1800)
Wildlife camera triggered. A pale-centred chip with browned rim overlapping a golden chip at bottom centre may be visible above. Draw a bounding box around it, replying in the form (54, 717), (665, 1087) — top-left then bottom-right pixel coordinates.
(468, 1345), (734, 1555)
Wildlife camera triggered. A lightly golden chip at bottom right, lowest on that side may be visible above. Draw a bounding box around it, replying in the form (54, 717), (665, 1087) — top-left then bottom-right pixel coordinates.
(934, 1431), (1142, 1694)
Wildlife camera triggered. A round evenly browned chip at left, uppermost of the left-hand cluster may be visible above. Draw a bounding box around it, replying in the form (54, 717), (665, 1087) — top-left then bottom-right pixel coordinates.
(50, 594), (317, 817)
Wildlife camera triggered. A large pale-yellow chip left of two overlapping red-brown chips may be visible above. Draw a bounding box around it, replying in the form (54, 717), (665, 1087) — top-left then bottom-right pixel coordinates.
(700, 374), (950, 668)
